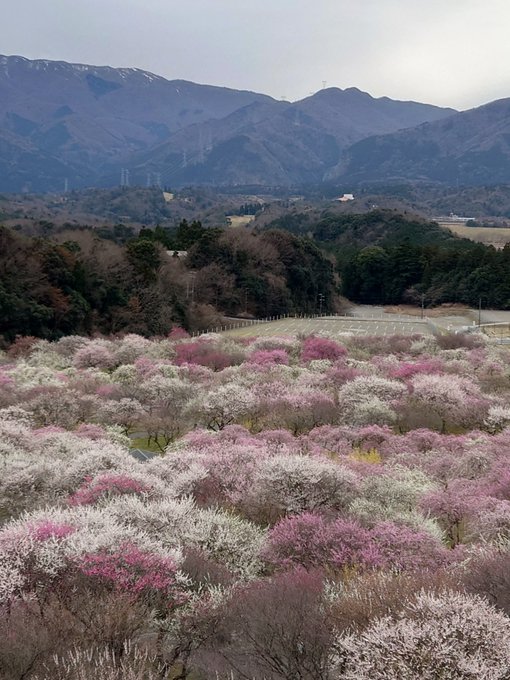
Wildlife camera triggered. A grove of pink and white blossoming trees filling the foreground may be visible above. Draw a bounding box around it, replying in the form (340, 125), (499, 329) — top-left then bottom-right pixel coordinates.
(0, 330), (510, 680)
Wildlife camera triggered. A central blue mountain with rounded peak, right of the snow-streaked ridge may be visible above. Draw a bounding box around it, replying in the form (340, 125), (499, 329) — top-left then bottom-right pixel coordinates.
(134, 88), (452, 186)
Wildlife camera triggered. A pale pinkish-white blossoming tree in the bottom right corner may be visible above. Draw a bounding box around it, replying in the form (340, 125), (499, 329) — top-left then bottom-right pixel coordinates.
(335, 591), (510, 680)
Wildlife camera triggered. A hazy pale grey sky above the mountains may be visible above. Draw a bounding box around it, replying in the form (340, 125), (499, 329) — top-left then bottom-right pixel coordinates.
(0, 0), (510, 109)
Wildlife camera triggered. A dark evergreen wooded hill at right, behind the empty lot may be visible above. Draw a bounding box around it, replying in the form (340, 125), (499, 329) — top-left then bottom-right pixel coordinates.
(264, 210), (510, 309)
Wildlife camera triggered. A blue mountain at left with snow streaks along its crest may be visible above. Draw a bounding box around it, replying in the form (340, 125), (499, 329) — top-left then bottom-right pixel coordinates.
(0, 56), (273, 191)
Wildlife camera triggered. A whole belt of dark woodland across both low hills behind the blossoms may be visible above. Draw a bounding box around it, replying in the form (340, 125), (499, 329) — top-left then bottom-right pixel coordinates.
(0, 211), (510, 342)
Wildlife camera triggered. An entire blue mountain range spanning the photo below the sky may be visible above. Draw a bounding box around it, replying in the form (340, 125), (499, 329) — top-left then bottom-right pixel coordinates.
(0, 56), (510, 192)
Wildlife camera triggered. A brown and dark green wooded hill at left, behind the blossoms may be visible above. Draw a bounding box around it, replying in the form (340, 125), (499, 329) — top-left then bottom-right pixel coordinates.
(0, 222), (336, 342)
